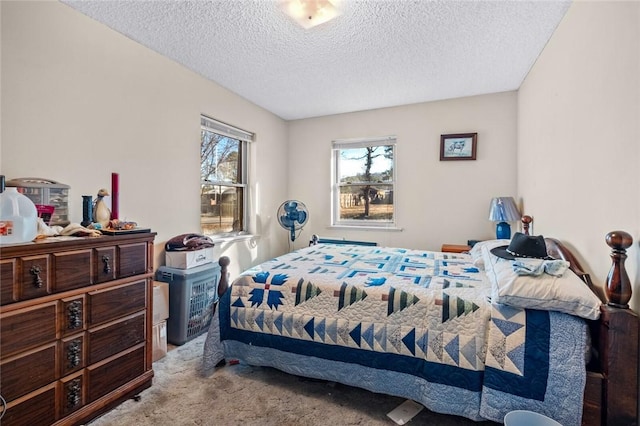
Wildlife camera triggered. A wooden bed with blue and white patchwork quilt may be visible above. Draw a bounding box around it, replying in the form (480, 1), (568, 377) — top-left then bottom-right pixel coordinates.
(204, 231), (638, 426)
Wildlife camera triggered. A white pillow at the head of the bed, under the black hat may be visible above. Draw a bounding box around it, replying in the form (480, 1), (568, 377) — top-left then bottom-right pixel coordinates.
(482, 243), (602, 319)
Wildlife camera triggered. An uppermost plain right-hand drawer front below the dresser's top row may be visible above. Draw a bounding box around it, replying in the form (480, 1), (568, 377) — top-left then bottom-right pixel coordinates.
(88, 279), (147, 326)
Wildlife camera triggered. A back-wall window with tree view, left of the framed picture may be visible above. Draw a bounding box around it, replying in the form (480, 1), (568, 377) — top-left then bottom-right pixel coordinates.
(332, 137), (396, 227)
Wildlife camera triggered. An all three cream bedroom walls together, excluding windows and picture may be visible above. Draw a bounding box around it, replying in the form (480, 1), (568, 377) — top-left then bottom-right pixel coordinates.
(0, 1), (640, 306)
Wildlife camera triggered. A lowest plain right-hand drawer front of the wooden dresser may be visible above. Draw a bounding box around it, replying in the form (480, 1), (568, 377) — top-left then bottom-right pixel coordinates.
(87, 345), (145, 403)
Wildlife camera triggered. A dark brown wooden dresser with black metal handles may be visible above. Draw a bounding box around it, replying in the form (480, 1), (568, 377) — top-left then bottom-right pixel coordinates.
(0, 233), (155, 426)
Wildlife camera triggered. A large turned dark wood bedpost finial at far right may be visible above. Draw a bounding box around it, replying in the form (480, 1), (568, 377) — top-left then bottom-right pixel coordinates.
(605, 231), (633, 309)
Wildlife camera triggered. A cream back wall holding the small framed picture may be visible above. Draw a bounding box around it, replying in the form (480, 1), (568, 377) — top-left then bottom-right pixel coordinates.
(289, 92), (517, 250)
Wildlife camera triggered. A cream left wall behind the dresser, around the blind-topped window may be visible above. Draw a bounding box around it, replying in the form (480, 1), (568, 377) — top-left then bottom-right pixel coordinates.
(0, 1), (288, 272)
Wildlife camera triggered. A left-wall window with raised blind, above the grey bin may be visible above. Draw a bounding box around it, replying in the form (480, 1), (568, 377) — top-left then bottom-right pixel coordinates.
(200, 116), (253, 235)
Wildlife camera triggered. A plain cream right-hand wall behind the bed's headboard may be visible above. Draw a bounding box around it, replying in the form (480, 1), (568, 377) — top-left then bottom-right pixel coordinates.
(518, 1), (640, 309)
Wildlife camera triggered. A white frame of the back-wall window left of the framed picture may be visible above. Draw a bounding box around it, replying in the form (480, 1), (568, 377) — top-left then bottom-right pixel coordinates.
(331, 136), (399, 230)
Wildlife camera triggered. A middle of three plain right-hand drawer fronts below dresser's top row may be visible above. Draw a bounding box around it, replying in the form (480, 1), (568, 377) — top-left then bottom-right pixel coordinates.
(89, 311), (146, 364)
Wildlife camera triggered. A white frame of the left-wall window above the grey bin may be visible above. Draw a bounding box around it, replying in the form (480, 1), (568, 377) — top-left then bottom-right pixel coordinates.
(200, 114), (255, 238)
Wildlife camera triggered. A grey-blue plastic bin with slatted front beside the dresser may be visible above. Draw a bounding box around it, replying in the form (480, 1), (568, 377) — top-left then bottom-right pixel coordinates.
(156, 263), (220, 345)
